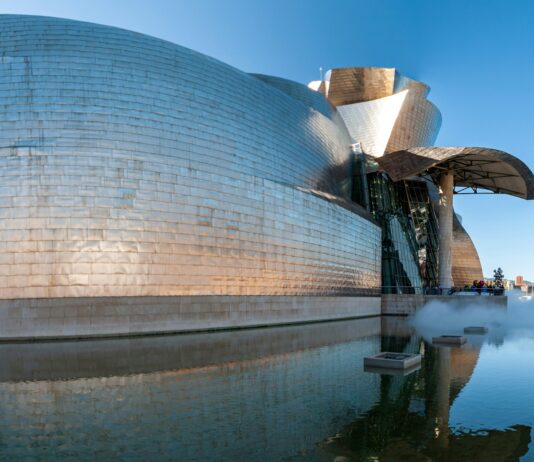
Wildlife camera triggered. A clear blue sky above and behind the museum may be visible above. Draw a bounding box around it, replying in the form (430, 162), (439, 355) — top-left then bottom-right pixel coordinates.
(0, 0), (534, 281)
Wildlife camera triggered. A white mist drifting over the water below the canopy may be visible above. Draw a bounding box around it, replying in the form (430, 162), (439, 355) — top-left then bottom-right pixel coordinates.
(409, 292), (534, 343)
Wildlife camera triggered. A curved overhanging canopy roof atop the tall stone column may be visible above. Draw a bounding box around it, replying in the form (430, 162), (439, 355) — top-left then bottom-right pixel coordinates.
(377, 147), (534, 199)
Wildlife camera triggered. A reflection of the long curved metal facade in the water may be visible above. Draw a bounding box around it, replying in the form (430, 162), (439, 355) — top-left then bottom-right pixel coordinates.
(0, 317), (386, 461)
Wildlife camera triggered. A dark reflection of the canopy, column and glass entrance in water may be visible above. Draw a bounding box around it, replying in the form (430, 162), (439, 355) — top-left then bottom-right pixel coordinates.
(320, 318), (531, 462)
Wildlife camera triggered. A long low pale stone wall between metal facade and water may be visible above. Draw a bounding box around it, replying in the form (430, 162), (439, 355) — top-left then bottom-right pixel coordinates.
(0, 295), (380, 341)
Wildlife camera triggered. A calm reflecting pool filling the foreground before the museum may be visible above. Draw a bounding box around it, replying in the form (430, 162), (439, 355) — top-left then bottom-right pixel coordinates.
(0, 302), (534, 462)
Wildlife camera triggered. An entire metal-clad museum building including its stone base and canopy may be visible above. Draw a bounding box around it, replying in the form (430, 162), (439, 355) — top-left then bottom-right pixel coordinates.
(0, 15), (534, 337)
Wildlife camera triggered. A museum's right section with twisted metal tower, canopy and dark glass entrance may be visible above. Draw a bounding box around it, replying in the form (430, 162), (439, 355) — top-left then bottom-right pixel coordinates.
(308, 67), (534, 291)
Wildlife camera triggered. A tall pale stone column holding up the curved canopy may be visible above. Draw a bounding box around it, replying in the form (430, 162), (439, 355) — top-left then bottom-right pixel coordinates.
(438, 172), (454, 289)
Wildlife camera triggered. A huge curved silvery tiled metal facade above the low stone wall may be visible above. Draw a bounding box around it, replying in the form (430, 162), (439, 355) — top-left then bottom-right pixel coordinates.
(0, 16), (381, 298)
